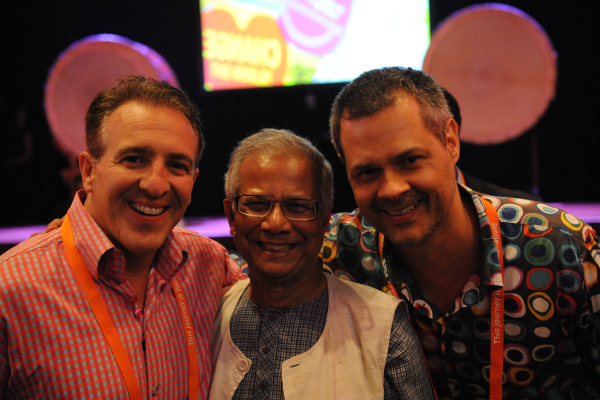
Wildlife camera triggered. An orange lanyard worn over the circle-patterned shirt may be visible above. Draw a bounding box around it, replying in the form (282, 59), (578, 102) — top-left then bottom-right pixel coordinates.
(379, 200), (504, 400)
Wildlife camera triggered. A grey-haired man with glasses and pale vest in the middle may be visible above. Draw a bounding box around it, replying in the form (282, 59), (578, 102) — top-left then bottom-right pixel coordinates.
(210, 129), (432, 400)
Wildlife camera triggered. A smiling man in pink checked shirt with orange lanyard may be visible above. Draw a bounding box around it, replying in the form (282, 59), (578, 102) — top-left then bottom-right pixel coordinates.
(0, 77), (240, 399)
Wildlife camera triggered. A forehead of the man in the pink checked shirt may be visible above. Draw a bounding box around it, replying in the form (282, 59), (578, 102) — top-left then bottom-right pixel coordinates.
(103, 102), (198, 159)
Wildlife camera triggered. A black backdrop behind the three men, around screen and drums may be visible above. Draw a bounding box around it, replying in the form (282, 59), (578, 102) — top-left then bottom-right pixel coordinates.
(0, 0), (600, 226)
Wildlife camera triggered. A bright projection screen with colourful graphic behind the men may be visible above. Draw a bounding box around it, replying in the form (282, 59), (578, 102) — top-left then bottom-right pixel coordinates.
(200, 0), (430, 91)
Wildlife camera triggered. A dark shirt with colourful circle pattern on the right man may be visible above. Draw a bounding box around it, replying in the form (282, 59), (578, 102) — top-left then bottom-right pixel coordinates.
(321, 186), (600, 400)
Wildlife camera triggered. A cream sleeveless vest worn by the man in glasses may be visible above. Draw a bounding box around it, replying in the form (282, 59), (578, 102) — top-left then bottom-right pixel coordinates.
(209, 274), (406, 400)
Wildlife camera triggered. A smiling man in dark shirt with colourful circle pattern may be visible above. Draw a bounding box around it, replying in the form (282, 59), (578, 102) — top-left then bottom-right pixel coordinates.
(322, 68), (600, 399)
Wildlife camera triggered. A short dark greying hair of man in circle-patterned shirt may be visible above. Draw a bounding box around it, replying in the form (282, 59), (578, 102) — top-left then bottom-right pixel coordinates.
(329, 67), (452, 160)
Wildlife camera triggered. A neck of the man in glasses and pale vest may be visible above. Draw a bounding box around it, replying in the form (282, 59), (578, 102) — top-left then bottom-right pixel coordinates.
(248, 262), (327, 309)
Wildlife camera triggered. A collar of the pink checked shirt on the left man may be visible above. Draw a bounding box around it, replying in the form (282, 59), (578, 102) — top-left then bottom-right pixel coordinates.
(68, 190), (188, 283)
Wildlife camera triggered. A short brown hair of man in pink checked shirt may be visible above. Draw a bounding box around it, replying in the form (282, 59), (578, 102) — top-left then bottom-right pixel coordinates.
(85, 75), (204, 168)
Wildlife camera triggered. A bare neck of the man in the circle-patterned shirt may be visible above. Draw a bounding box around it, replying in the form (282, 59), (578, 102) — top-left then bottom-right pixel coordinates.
(394, 187), (483, 315)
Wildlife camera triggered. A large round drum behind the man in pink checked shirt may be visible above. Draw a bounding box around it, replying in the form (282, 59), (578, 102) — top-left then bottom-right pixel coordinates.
(45, 34), (179, 157)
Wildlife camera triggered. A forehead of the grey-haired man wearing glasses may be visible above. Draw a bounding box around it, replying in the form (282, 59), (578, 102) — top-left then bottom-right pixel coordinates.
(239, 153), (317, 196)
